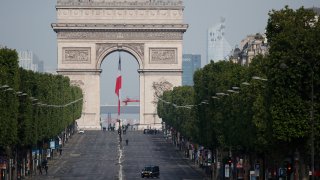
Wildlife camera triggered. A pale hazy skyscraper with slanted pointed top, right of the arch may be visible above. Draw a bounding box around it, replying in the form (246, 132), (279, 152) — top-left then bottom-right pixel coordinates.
(207, 18), (232, 64)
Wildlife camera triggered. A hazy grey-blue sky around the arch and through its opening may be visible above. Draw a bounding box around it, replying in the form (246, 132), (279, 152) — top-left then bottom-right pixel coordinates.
(0, 0), (320, 114)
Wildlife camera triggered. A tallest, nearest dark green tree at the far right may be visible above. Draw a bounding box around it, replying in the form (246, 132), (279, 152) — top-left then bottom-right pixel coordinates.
(267, 6), (320, 148)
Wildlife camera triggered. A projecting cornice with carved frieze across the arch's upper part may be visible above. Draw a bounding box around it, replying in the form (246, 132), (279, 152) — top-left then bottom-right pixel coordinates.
(52, 23), (188, 40)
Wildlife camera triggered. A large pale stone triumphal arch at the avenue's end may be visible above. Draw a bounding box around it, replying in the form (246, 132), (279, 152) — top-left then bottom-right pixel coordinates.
(52, 0), (187, 129)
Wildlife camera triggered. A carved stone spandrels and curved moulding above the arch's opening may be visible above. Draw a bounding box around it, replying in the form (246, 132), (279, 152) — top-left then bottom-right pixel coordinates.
(96, 43), (144, 69)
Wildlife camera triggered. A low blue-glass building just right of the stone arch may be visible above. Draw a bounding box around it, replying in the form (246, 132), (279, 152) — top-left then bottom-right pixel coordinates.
(182, 54), (201, 86)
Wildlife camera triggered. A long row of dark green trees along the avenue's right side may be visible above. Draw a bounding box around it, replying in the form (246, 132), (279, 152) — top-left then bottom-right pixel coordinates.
(157, 7), (320, 177)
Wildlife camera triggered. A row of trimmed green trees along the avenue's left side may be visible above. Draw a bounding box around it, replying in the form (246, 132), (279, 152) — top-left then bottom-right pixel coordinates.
(0, 48), (83, 153)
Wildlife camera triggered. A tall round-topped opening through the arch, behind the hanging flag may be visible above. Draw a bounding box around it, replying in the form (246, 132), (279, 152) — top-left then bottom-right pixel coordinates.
(100, 50), (140, 130)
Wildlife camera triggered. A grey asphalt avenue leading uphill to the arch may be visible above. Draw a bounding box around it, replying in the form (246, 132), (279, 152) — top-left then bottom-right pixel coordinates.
(33, 131), (204, 180)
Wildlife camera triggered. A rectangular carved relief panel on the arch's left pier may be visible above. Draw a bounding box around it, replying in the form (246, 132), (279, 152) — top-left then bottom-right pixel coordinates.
(62, 47), (91, 64)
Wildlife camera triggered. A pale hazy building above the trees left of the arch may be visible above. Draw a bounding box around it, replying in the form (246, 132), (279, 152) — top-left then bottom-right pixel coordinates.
(18, 51), (44, 72)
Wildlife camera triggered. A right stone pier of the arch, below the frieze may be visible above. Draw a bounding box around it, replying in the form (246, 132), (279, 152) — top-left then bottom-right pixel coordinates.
(140, 42), (182, 128)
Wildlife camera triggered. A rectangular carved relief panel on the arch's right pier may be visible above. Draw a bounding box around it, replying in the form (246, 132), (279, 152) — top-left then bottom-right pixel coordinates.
(150, 48), (177, 64)
